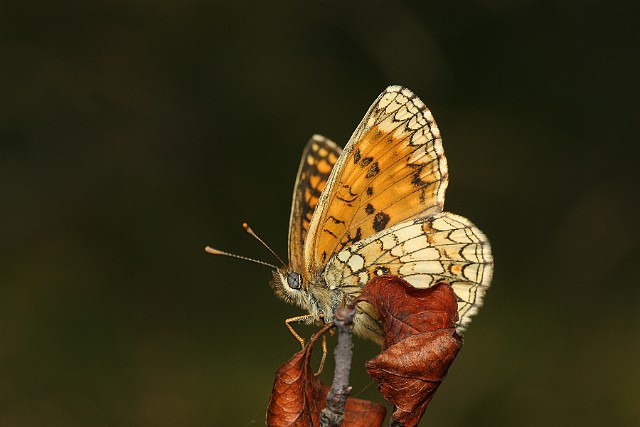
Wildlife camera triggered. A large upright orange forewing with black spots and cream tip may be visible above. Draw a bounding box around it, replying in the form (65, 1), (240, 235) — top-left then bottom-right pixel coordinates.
(303, 86), (448, 280)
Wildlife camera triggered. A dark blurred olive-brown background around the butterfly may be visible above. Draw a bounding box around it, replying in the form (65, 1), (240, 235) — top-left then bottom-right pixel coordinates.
(0, 1), (640, 426)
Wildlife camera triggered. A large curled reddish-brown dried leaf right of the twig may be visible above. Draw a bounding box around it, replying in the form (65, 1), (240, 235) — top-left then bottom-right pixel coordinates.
(358, 276), (462, 427)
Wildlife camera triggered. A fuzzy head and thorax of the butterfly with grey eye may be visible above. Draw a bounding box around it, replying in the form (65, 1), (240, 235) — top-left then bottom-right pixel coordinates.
(271, 267), (341, 322)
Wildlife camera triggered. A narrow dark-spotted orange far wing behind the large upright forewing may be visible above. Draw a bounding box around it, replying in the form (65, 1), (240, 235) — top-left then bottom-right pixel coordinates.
(289, 135), (342, 272)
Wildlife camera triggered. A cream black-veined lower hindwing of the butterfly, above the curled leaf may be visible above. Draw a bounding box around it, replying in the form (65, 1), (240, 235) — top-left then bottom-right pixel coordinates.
(325, 212), (493, 331)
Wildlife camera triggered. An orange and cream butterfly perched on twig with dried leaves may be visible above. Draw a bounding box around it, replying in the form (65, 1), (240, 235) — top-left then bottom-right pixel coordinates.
(271, 86), (493, 343)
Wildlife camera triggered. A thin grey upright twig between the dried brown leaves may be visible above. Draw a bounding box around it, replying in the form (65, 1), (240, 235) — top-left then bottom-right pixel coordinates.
(320, 307), (356, 427)
